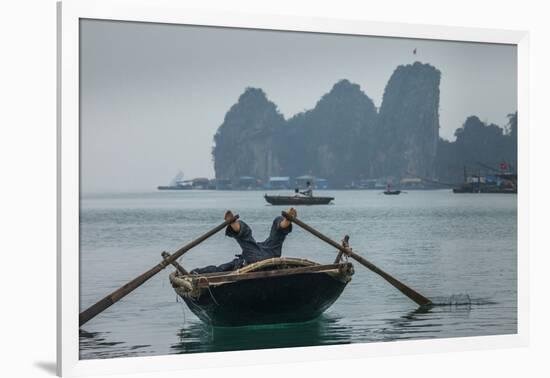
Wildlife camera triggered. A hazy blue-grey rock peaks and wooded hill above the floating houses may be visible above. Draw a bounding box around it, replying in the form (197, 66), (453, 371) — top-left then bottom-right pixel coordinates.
(213, 62), (498, 187)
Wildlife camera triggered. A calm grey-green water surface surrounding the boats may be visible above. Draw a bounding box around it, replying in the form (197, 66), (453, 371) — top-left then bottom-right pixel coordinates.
(80, 190), (517, 359)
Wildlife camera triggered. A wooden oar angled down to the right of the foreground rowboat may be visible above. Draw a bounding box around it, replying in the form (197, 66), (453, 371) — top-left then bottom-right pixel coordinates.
(282, 211), (432, 306)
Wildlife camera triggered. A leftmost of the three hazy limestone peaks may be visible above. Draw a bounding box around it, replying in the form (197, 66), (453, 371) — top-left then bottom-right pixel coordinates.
(212, 88), (285, 179)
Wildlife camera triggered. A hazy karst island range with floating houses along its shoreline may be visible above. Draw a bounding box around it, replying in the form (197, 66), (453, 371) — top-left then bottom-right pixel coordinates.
(159, 62), (517, 193)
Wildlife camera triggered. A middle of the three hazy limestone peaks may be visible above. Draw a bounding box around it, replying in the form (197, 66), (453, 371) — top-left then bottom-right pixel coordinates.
(281, 80), (376, 186)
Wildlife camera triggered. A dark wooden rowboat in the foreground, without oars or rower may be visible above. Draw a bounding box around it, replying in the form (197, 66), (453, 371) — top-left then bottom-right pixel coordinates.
(170, 258), (354, 327)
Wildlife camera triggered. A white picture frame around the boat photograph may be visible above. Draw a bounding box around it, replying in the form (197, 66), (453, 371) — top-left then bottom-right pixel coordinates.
(57, 0), (529, 376)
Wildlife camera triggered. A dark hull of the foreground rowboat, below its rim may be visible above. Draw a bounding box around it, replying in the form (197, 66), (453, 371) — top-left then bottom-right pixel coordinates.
(171, 263), (353, 327)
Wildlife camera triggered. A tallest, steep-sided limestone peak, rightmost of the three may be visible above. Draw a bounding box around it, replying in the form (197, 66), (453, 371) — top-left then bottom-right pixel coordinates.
(370, 62), (441, 177)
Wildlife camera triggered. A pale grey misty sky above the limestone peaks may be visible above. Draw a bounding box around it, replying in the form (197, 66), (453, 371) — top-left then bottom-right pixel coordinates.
(80, 20), (517, 192)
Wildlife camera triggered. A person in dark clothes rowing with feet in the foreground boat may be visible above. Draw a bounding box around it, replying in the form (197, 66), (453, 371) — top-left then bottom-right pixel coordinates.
(191, 208), (297, 274)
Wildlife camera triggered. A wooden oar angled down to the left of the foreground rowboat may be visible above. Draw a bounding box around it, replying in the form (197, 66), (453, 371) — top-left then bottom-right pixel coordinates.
(79, 215), (239, 326)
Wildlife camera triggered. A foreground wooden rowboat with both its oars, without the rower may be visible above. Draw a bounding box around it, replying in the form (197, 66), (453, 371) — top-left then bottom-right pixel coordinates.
(78, 211), (432, 327)
